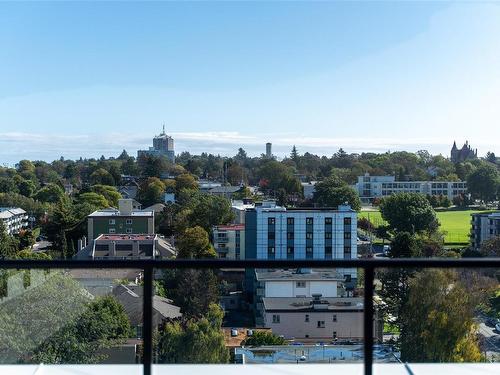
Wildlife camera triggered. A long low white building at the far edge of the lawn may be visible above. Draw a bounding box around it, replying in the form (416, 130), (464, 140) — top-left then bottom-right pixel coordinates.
(354, 173), (467, 202)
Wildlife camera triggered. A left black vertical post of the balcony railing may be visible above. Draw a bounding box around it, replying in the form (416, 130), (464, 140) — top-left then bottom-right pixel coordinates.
(142, 264), (153, 375)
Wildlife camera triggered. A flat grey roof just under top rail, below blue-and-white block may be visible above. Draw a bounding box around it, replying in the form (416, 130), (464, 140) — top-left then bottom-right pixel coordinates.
(255, 268), (344, 281)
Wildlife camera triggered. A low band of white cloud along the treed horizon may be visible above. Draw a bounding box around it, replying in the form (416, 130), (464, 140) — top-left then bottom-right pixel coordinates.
(0, 132), (489, 165)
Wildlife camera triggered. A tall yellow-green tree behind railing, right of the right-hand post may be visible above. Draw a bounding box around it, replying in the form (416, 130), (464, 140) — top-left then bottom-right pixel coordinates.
(401, 269), (481, 362)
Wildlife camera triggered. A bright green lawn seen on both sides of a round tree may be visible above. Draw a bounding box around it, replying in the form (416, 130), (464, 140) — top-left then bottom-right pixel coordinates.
(359, 210), (488, 243)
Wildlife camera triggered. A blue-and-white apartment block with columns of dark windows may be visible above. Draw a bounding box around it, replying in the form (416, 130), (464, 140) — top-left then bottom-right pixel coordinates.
(245, 201), (357, 278)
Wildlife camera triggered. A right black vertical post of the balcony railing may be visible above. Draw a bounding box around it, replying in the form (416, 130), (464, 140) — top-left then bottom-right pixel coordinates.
(363, 265), (374, 375)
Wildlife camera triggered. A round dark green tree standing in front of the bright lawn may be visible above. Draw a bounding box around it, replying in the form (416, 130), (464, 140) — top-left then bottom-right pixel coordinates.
(380, 193), (439, 233)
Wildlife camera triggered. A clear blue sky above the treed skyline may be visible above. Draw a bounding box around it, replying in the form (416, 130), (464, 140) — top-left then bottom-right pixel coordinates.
(0, 2), (500, 164)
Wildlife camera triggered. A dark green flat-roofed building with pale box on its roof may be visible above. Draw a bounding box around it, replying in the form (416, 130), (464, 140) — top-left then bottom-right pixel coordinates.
(87, 199), (155, 243)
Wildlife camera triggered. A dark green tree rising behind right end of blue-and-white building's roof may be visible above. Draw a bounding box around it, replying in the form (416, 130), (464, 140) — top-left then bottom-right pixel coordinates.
(313, 177), (361, 211)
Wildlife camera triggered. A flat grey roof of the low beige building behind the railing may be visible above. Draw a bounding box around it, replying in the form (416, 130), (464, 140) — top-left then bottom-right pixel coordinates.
(262, 297), (363, 312)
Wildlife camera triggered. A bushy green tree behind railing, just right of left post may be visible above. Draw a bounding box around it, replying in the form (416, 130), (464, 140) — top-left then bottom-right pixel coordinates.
(157, 304), (229, 363)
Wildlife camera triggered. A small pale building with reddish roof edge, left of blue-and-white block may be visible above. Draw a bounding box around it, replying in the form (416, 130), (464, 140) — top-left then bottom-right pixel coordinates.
(212, 224), (245, 259)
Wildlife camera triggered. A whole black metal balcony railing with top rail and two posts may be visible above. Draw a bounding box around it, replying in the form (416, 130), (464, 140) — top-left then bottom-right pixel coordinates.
(0, 258), (500, 375)
